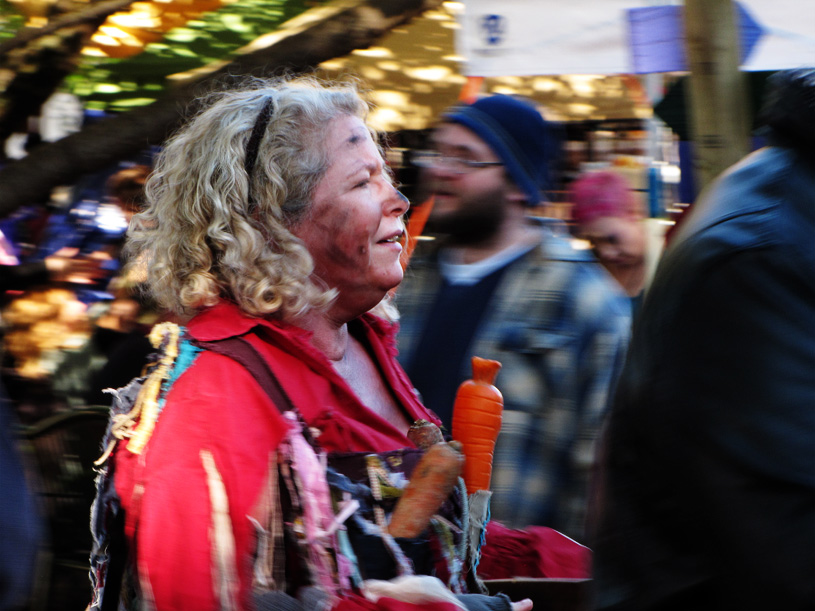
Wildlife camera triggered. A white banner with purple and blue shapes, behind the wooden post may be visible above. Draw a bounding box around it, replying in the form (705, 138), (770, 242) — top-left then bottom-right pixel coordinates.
(456, 0), (815, 76)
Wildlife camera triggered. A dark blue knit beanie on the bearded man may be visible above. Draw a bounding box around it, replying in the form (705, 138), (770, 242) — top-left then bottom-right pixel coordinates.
(442, 94), (560, 206)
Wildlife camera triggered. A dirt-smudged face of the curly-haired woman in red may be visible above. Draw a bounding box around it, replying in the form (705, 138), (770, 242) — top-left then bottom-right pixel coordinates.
(293, 115), (409, 316)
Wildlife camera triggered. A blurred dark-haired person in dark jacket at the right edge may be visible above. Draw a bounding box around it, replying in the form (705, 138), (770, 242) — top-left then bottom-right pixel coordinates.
(592, 68), (815, 611)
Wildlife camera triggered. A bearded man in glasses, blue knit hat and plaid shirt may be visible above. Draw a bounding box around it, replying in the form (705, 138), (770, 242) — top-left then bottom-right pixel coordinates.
(396, 95), (630, 540)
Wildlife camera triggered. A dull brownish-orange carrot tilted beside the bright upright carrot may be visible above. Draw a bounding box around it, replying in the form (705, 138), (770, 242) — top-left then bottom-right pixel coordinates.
(388, 442), (464, 538)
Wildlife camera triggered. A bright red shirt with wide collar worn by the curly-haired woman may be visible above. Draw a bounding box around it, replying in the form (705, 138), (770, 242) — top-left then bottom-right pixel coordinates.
(115, 303), (441, 611)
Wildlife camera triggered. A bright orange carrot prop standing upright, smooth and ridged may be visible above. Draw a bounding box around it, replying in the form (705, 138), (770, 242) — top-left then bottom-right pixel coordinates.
(453, 356), (504, 494)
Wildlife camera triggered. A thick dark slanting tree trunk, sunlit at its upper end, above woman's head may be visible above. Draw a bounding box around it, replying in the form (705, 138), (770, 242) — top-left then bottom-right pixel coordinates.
(0, 0), (442, 217)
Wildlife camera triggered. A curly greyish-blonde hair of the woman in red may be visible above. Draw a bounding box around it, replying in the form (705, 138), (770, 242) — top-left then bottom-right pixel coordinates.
(126, 77), (376, 320)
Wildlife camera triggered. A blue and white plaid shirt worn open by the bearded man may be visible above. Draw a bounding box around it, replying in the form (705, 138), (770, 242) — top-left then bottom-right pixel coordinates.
(396, 224), (631, 539)
